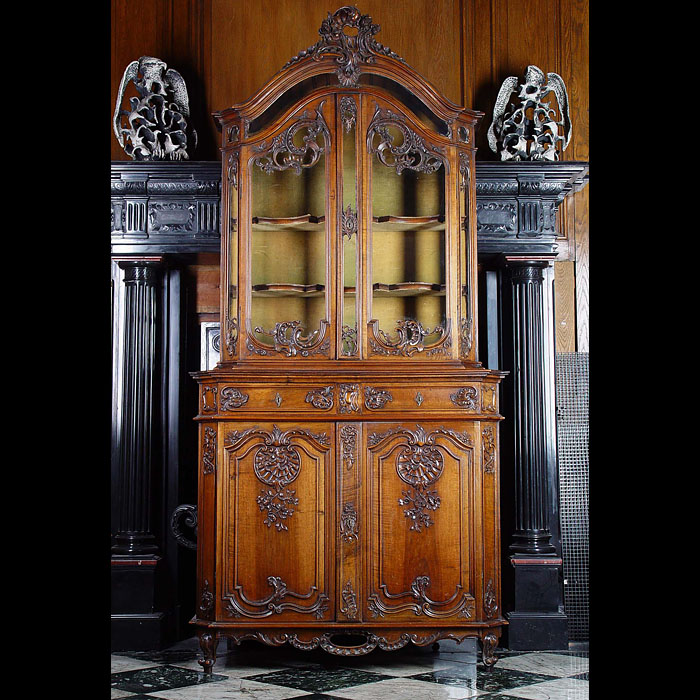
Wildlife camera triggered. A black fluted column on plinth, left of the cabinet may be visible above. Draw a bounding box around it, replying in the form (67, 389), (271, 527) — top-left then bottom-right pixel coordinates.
(111, 257), (169, 650)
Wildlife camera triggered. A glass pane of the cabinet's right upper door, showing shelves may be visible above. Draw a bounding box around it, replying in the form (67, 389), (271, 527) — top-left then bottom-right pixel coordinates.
(368, 117), (446, 345)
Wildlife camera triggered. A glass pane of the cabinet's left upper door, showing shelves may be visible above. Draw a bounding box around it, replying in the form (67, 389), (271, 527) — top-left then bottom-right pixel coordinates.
(250, 108), (330, 346)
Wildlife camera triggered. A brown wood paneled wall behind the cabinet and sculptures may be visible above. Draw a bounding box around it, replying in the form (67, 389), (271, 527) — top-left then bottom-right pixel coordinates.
(110, 0), (589, 352)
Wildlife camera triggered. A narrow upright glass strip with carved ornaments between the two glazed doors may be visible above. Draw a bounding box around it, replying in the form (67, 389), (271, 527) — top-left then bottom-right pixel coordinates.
(338, 95), (358, 357)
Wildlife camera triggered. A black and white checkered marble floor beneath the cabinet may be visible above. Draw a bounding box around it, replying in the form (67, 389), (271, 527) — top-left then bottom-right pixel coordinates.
(112, 638), (588, 700)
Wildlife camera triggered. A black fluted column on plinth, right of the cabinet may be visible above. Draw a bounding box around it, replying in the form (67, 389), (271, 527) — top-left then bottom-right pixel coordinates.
(503, 255), (568, 650)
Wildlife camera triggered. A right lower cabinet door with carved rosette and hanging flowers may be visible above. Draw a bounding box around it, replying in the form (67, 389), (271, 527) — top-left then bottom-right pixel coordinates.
(364, 423), (481, 624)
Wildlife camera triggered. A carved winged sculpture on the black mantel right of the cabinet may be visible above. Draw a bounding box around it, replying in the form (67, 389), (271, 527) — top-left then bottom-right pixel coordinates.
(487, 66), (571, 161)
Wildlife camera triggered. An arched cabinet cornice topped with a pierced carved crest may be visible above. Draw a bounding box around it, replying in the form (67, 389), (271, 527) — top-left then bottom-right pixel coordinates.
(213, 6), (483, 131)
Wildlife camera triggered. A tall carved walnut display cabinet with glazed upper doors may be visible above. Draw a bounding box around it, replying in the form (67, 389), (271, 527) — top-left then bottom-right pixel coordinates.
(192, 7), (505, 672)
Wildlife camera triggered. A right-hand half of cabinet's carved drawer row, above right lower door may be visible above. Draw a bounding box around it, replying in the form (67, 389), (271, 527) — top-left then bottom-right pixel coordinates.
(362, 382), (498, 414)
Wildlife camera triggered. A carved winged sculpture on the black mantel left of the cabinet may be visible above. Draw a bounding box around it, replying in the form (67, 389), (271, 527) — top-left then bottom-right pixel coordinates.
(113, 56), (197, 160)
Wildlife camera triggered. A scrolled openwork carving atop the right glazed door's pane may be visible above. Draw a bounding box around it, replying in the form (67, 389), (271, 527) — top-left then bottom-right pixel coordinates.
(367, 105), (449, 175)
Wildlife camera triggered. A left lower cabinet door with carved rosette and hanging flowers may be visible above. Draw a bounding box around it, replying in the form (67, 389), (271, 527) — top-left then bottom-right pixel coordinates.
(219, 423), (334, 622)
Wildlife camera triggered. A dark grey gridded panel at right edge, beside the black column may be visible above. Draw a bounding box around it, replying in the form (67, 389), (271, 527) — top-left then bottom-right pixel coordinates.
(555, 352), (589, 642)
